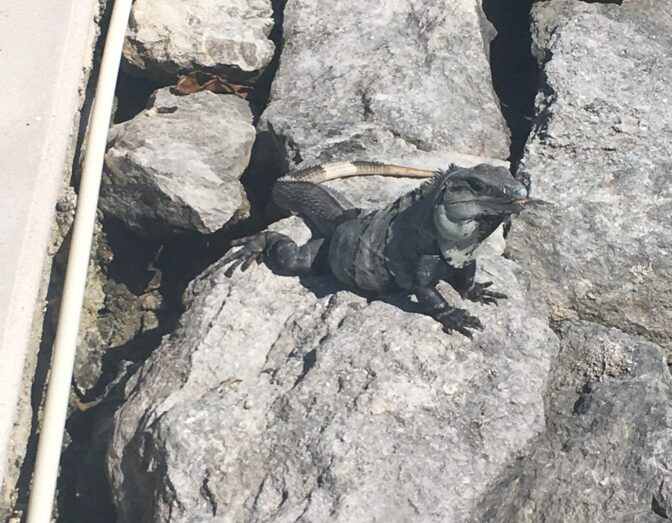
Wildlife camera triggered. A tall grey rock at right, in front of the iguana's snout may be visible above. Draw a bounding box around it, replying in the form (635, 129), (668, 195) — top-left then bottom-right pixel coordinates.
(509, 0), (672, 350)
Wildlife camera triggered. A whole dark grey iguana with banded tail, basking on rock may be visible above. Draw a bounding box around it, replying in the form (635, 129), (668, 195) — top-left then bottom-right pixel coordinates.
(222, 162), (527, 338)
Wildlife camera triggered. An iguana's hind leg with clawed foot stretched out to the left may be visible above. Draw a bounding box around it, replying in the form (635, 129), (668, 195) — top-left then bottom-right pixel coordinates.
(222, 231), (327, 277)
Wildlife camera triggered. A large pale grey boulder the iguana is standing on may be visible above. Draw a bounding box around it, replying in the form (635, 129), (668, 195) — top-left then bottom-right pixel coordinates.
(108, 179), (557, 521)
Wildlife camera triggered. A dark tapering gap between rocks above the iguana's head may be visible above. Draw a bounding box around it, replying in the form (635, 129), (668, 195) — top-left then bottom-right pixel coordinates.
(483, 0), (539, 172)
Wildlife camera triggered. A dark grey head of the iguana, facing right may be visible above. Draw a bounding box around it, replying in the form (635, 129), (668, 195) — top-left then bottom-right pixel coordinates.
(434, 164), (527, 240)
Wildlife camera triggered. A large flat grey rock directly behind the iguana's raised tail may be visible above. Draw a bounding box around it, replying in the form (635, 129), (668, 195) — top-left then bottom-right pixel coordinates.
(262, 0), (509, 168)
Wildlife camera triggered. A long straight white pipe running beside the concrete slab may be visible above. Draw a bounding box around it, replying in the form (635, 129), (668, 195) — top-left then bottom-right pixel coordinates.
(27, 0), (132, 523)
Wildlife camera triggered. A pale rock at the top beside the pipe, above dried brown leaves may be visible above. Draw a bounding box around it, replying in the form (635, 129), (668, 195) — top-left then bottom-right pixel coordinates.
(124, 0), (274, 85)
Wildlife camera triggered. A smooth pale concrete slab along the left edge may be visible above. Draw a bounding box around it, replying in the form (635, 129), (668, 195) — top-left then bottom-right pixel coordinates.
(0, 0), (99, 510)
